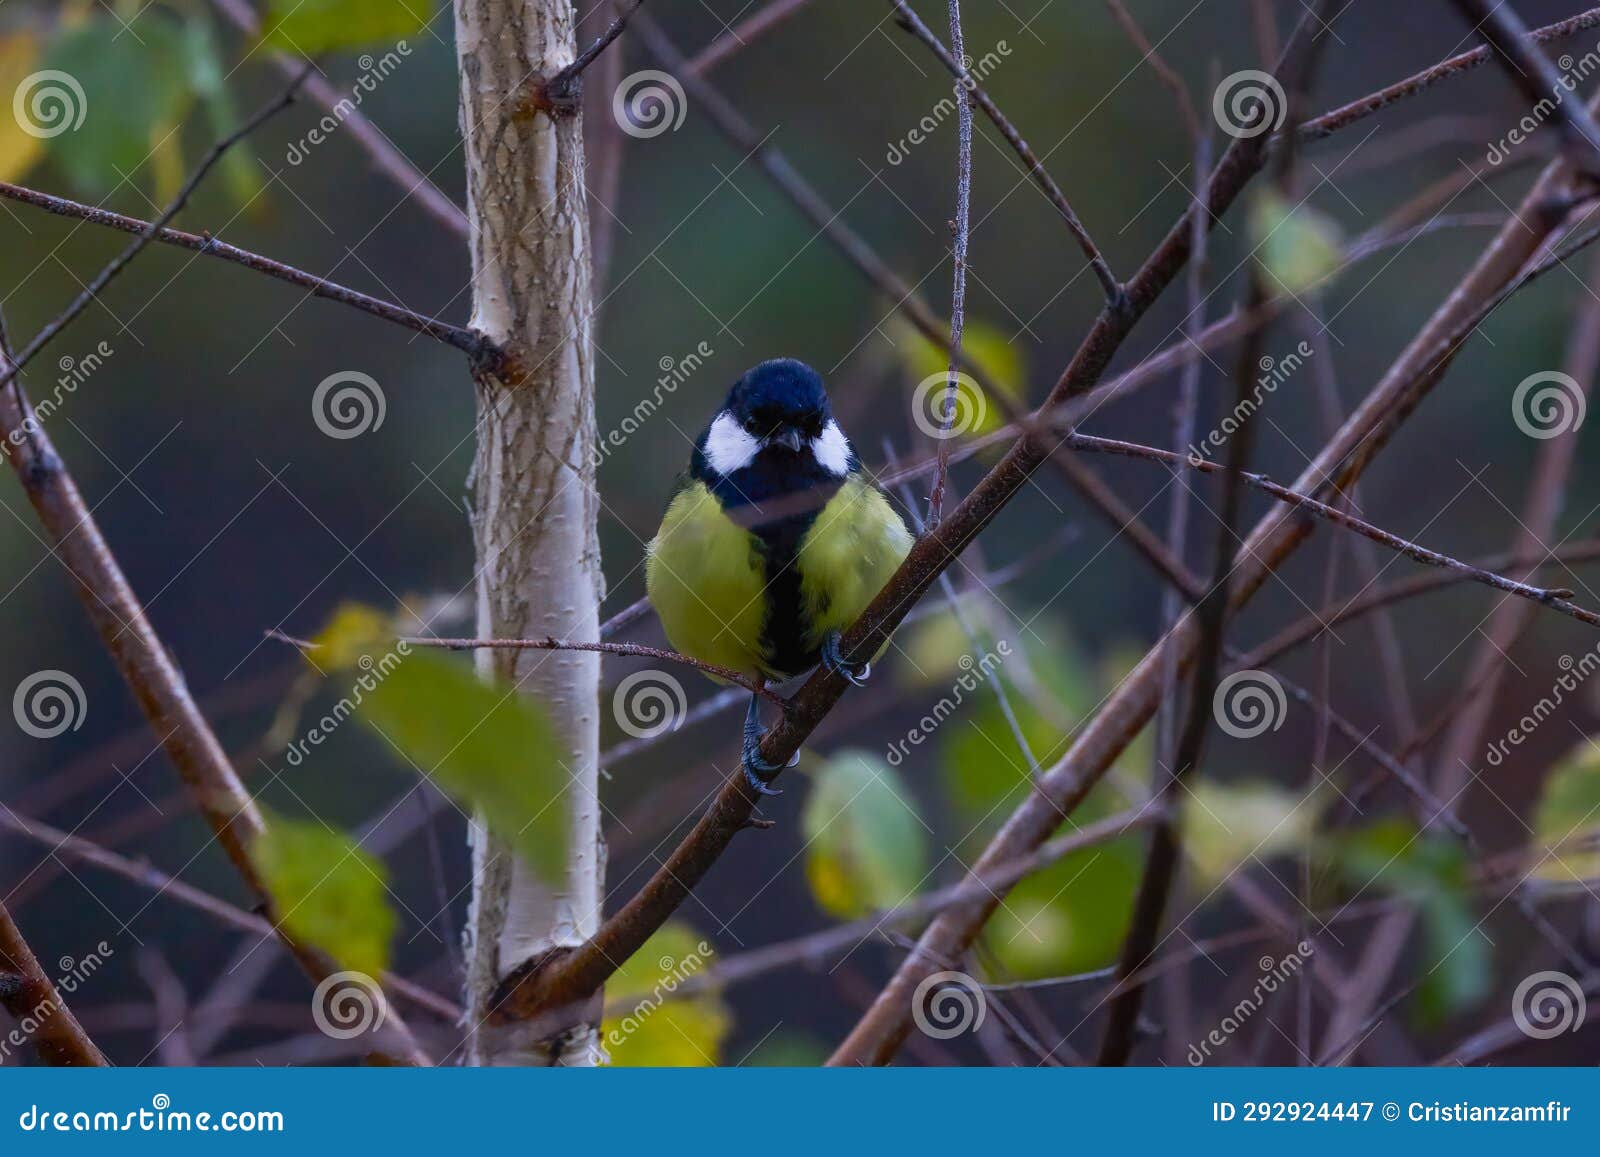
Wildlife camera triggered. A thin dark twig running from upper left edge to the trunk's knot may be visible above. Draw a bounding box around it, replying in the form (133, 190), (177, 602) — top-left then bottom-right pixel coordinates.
(0, 181), (501, 365)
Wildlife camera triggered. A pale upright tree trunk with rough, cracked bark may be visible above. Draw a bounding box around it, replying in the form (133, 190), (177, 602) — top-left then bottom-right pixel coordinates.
(456, 0), (605, 1064)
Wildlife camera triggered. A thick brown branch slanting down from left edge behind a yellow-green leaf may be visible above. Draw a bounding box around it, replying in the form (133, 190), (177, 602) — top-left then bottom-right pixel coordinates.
(0, 325), (427, 1064)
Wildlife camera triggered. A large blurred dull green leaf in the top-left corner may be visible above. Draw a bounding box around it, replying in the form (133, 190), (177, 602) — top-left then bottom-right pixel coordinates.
(45, 14), (192, 197)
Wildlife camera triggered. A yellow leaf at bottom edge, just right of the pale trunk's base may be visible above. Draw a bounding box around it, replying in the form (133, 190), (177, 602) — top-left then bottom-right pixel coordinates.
(600, 922), (733, 1067)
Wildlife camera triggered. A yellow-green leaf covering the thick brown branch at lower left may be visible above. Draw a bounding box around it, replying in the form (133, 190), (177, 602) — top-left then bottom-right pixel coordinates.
(250, 816), (398, 976)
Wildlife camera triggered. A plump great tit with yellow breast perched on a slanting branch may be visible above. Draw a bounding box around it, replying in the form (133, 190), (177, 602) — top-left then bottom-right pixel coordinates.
(645, 358), (912, 795)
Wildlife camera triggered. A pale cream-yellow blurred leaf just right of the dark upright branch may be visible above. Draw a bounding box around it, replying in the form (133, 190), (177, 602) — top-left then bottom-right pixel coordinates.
(1182, 778), (1317, 893)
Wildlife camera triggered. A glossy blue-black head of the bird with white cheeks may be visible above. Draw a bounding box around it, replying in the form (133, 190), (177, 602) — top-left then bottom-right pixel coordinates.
(690, 357), (858, 501)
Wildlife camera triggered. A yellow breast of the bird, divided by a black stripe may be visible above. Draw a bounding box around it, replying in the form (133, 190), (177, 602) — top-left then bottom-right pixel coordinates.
(645, 477), (912, 679)
